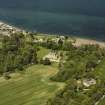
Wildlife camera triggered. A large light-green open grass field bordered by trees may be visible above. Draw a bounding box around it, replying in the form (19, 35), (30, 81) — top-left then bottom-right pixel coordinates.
(0, 64), (64, 105)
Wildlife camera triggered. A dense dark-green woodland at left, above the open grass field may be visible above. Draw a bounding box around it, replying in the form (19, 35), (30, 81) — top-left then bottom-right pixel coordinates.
(0, 33), (37, 75)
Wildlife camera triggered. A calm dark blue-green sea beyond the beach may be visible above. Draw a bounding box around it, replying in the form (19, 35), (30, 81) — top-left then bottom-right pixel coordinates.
(0, 0), (105, 40)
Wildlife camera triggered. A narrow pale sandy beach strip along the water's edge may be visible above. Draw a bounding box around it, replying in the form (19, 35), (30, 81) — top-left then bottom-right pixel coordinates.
(0, 20), (105, 48)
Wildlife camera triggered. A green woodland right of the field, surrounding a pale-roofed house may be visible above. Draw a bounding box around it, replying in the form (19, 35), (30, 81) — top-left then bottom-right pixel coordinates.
(46, 45), (105, 105)
